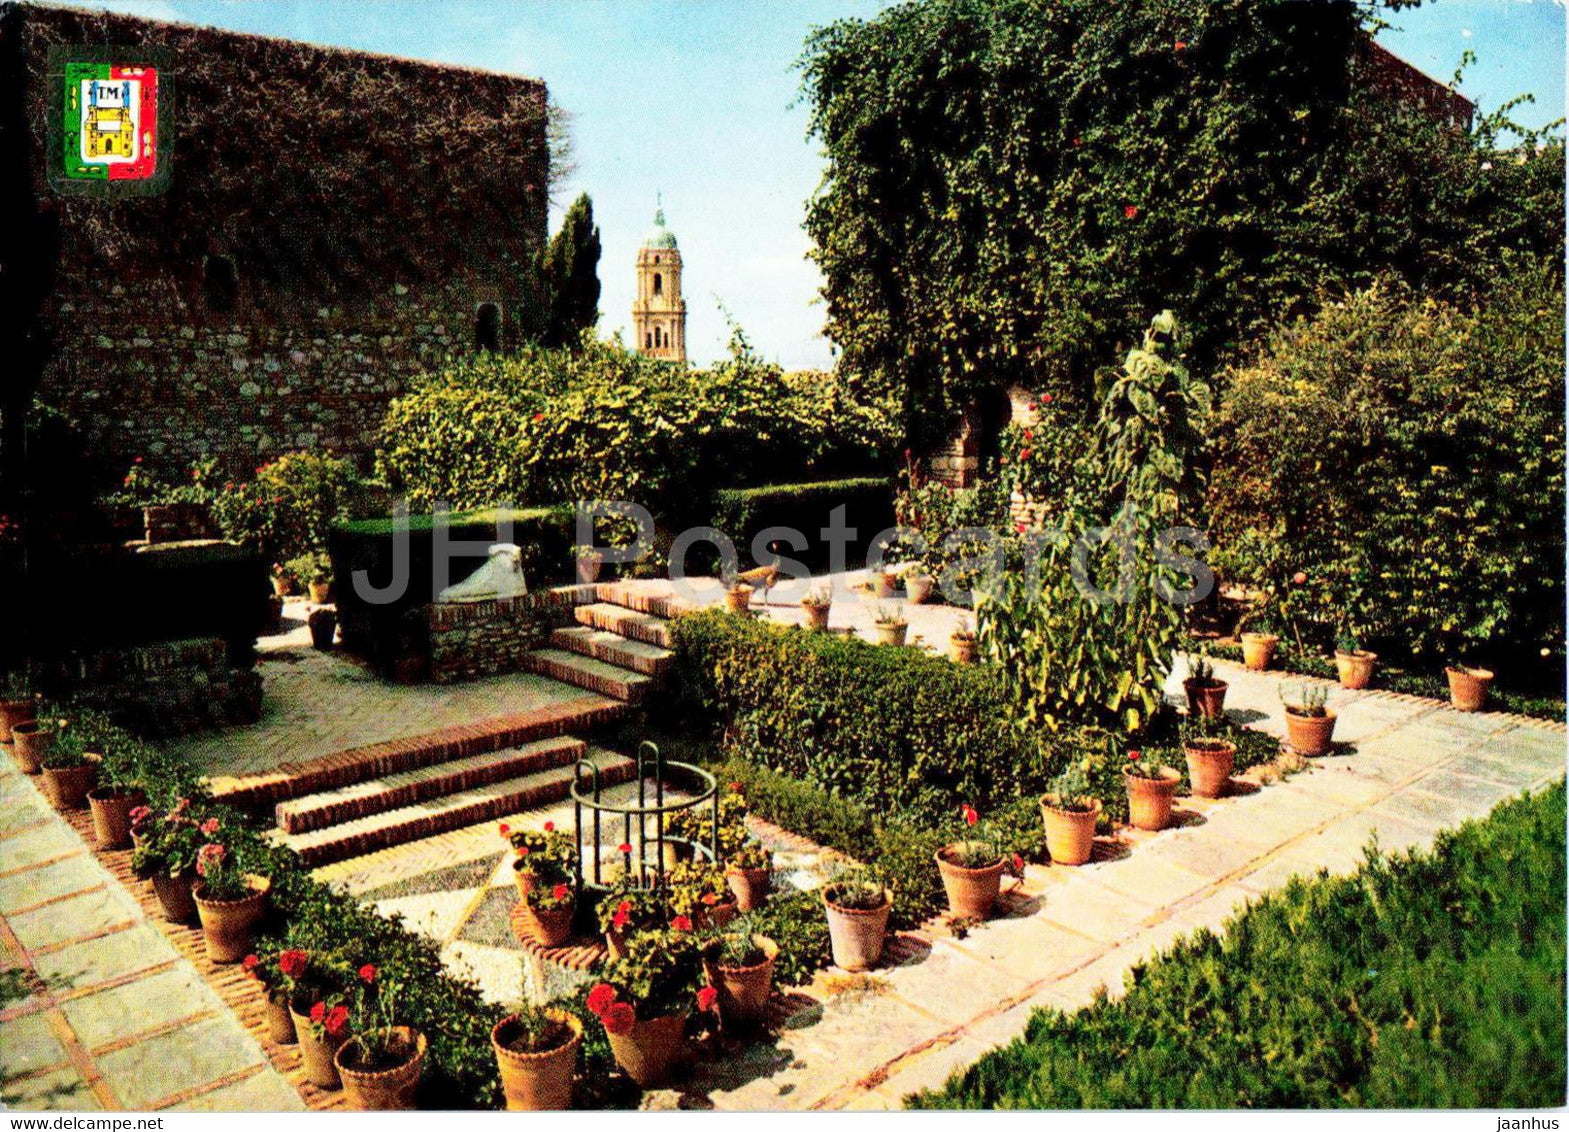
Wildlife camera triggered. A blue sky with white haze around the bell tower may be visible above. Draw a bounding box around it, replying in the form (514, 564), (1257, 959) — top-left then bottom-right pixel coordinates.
(55, 0), (1564, 367)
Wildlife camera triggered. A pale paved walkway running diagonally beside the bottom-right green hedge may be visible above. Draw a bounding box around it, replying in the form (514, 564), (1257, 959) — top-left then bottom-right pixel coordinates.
(690, 664), (1566, 1108)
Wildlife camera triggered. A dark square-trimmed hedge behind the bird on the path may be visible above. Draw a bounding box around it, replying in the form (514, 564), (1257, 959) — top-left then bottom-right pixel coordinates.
(711, 477), (894, 575)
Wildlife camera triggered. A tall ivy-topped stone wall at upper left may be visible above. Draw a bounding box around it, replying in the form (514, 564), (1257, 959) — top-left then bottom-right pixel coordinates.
(0, 5), (549, 473)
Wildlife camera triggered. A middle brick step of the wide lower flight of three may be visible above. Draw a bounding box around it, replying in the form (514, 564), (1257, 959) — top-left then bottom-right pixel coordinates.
(276, 735), (588, 834)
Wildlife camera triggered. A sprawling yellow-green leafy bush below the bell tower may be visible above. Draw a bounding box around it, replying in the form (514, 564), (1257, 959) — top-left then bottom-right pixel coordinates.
(377, 332), (893, 514)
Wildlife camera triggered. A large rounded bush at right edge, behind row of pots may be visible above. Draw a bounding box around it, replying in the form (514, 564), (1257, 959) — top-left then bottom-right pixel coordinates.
(1210, 261), (1564, 686)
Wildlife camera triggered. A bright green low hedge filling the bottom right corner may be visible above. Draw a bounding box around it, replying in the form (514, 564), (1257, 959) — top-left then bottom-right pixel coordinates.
(912, 782), (1566, 1108)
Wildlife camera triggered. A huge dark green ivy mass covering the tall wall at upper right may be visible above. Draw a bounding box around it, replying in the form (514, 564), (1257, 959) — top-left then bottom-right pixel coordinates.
(803, 0), (1564, 440)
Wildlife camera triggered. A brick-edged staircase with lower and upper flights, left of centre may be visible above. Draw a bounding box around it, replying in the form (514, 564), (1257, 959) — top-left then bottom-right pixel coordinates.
(212, 582), (699, 868)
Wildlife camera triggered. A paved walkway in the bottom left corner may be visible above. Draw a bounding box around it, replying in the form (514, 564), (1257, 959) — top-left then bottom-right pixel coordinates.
(0, 752), (304, 1112)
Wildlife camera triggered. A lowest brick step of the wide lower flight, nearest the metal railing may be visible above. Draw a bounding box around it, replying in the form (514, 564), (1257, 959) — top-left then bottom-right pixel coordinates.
(268, 750), (637, 868)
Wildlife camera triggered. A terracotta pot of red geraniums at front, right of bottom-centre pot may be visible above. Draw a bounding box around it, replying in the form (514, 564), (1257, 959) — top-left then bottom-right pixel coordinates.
(588, 929), (717, 1088)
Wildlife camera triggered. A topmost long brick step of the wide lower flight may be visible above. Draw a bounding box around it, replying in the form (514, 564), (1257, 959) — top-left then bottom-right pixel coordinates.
(209, 694), (628, 810)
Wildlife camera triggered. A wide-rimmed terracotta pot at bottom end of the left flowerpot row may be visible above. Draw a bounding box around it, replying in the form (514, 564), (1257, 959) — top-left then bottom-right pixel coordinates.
(333, 962), (427, 1112)
